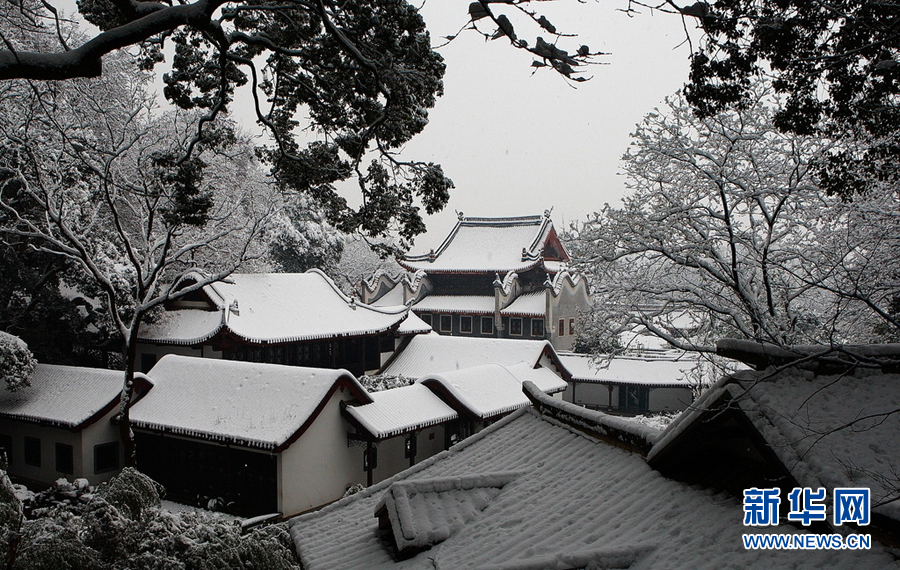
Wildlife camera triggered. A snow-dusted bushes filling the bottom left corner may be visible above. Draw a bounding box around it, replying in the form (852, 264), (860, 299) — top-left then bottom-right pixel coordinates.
(0, 469), (300, 570)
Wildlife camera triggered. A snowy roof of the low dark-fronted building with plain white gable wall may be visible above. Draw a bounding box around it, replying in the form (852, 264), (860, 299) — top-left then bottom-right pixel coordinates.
(131, 354), (371, 451)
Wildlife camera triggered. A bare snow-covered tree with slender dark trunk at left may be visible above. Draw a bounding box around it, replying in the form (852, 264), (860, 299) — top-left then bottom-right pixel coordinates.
(0, 44), (275, 463)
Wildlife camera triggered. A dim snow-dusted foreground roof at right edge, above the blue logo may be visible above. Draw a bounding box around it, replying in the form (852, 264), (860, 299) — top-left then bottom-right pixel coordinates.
(649, 360), (900, 521)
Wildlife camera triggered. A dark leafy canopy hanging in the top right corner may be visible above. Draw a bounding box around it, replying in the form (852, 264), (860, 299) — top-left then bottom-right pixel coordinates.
(681, 0), (900, 197)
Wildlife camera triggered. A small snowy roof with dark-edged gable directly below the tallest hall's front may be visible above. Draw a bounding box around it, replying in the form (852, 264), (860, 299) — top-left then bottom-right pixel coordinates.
(419, 363), (566, 419)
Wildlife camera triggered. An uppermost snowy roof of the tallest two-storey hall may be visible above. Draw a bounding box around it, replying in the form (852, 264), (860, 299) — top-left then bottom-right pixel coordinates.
(398, 215), (568, 273)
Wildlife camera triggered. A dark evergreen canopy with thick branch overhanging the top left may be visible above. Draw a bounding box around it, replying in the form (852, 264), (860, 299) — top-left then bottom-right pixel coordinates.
(0, 0), (452, 246)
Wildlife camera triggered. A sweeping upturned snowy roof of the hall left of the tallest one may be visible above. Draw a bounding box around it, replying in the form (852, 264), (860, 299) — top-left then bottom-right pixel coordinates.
(140, 269), (408, 345)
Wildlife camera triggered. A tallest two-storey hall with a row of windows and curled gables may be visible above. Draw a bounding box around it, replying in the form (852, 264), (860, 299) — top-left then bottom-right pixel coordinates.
(361, 212), (590, 350)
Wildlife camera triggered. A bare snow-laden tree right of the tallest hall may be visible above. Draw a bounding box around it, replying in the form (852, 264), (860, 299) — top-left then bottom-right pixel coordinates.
(572, 85), (897, 352)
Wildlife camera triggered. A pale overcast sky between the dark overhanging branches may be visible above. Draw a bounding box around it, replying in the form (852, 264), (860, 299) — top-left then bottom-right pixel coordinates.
(54, 0), (694, 252)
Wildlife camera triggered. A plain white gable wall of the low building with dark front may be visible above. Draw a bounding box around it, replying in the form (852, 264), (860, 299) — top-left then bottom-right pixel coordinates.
(278, 388), (366, 515)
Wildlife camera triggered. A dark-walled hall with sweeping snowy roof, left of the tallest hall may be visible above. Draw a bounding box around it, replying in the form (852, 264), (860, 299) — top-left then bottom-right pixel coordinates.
(138, 269), (431, 374)
